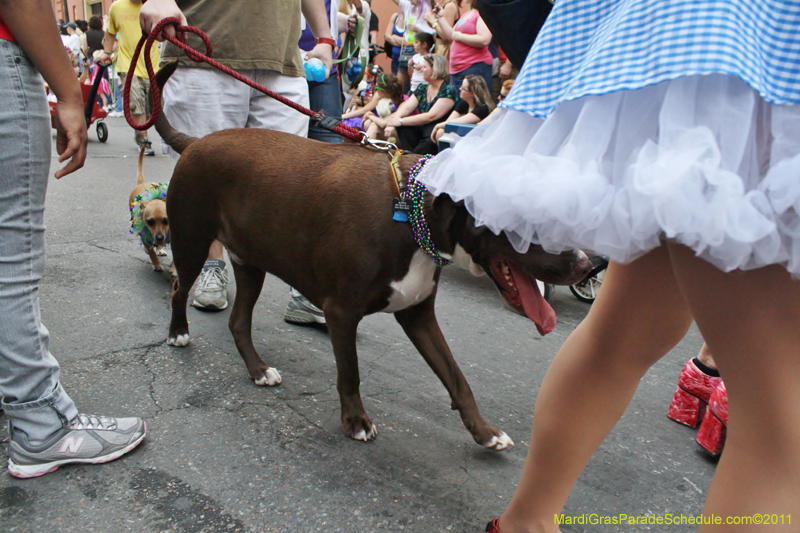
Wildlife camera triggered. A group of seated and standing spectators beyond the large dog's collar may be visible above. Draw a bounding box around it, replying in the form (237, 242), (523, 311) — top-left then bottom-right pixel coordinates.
(344, 0), (513, 155)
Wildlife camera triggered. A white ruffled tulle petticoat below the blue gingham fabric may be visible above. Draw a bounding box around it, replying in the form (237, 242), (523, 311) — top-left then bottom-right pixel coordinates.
(420, 74), (800, 277)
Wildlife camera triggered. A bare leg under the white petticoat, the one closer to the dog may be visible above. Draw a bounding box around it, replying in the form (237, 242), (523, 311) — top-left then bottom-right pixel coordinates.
(500, 246), (692, 533)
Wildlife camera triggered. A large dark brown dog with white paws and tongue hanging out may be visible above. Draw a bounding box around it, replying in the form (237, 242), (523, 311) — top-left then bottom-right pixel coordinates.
(156, 60), (591, 450)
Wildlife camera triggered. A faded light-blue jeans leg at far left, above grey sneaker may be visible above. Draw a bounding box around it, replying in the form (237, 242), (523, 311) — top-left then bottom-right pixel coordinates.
(0, 39), (78, 441)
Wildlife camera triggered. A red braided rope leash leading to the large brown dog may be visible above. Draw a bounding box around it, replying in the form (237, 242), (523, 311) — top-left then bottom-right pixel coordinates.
(122, 17), (365, 143)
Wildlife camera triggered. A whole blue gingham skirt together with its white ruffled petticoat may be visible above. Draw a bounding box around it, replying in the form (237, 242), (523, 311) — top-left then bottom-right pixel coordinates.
(420, 0), (800, 277)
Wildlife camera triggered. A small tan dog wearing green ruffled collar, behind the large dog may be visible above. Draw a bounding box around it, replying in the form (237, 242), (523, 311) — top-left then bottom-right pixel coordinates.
(129, 147), (169, 272)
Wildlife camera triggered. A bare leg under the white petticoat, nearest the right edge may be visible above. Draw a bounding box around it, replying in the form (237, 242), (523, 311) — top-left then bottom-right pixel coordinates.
(669, 245), (800, 532)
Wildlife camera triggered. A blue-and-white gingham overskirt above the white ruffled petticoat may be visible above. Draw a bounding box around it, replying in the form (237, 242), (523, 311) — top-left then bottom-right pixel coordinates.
(503, 0), (800, 116)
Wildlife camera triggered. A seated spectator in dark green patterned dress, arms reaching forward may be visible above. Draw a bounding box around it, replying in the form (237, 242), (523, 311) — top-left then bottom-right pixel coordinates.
(372, 54), (458, 155)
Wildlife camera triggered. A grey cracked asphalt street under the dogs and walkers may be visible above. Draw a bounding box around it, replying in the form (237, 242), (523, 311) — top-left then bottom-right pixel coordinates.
(0, 114), (715, 533)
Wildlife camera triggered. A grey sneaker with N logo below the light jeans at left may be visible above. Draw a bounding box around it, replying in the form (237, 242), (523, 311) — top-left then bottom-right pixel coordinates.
(8, 414), (147, 478)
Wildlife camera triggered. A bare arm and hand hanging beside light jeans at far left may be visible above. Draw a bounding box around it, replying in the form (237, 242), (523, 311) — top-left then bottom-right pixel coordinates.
(0, 0), (89, 178)
